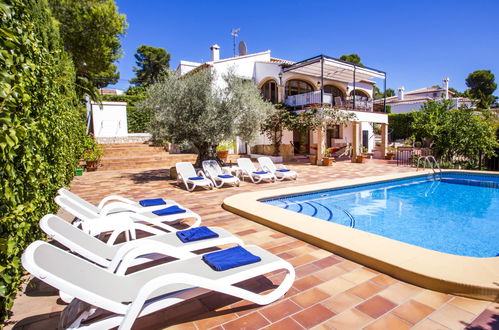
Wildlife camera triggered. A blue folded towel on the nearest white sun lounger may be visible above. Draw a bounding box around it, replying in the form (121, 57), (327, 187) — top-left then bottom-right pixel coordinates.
(203, 246), (262, 271)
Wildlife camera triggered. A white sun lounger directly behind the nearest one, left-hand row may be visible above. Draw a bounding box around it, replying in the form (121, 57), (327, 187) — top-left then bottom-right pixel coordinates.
(40, 214), (244, 272)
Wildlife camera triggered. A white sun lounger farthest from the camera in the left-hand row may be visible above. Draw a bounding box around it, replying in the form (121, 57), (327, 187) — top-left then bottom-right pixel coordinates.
(57, 188), (180, 214)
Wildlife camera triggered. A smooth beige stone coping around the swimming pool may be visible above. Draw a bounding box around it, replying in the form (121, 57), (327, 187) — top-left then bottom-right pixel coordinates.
(222, 170), (499, 302)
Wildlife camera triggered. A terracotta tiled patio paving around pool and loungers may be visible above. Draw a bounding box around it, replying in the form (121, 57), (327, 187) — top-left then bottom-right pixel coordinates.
(6, 160), (499, 330)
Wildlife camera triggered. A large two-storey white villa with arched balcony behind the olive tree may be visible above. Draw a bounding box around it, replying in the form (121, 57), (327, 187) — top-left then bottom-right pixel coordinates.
(177, 45), (388, 164)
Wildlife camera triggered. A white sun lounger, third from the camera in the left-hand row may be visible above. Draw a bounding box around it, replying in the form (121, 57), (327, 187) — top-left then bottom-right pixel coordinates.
(55, 195), (201, 239)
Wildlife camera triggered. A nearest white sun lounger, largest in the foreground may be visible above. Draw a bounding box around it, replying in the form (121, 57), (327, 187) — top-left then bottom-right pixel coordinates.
(22, 241), (295, 330)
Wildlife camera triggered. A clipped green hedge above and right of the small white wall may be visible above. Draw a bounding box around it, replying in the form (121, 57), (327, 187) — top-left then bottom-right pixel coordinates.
(102, 94), (149, 133)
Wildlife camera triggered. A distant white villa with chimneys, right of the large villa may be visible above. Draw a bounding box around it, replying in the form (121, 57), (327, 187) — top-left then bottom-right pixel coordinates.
(386, 78), (473, 113)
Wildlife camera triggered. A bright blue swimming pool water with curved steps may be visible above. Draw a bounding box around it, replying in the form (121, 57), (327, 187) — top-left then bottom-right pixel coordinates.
(261, 172), (499, 257)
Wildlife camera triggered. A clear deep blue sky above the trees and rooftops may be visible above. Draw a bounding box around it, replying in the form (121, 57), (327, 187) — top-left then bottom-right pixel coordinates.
(110, 0), (499, 96)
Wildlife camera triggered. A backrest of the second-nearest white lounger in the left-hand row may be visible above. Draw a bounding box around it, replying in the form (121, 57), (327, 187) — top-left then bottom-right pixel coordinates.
(40, 214), (115, 266)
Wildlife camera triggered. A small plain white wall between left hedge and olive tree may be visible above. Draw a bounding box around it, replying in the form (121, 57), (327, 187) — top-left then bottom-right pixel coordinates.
(90, 102), (128, 138)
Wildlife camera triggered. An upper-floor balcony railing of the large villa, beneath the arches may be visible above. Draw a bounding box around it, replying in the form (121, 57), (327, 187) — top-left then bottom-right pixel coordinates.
(284, 91), (373, 112)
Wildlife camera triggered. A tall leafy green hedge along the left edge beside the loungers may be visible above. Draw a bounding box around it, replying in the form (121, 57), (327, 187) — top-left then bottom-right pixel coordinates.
(0, 0), (84, 320)
